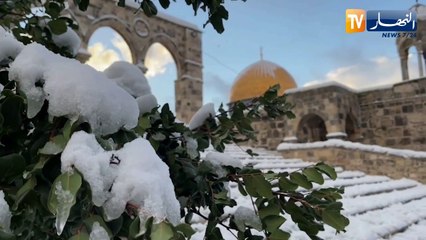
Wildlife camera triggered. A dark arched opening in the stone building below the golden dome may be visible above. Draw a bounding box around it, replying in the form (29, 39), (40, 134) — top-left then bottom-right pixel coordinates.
(297, 114), (327, 143)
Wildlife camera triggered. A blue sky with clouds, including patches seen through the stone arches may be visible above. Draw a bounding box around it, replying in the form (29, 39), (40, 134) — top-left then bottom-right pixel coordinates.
(89, 0), (426, 109)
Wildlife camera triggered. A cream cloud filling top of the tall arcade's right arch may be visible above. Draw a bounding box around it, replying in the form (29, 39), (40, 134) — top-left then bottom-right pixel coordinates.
(145, 43), (174, 78)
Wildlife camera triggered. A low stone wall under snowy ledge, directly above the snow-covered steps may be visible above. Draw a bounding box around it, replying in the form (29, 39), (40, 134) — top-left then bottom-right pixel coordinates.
(280, 147), (426, 183)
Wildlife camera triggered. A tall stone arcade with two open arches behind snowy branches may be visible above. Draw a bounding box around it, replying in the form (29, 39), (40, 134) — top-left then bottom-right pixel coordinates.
(66, 0), (203, 122)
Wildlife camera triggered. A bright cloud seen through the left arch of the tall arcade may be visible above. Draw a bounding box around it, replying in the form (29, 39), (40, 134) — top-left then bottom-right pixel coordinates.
(86, 33), (132, 71)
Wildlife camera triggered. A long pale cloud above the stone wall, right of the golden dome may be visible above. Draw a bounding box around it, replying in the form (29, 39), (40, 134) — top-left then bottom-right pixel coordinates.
(304, 56), (418, 89)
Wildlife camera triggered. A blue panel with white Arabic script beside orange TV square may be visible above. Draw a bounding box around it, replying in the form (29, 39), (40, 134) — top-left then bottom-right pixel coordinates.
(367, 10), (417, 32)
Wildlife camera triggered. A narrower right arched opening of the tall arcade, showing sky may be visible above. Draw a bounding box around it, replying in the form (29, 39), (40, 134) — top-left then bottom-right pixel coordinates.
(144, 43), (178, 112)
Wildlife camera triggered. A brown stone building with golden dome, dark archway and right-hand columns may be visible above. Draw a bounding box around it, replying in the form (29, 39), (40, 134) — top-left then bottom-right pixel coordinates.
(230, 4), (426, 151)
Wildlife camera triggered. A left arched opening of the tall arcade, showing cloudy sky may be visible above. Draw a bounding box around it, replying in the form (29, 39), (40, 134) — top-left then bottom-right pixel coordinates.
(86, 27), (133, 71)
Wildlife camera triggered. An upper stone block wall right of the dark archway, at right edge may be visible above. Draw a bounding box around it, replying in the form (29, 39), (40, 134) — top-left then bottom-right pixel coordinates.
(358, 78), (426, 151)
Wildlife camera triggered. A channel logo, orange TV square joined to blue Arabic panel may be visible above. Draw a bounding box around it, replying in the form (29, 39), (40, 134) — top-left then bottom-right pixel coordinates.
(346, 9), (417, 33)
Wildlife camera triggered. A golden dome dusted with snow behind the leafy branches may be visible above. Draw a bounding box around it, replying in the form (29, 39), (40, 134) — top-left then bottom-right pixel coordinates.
(230, 60), (297, 102)
